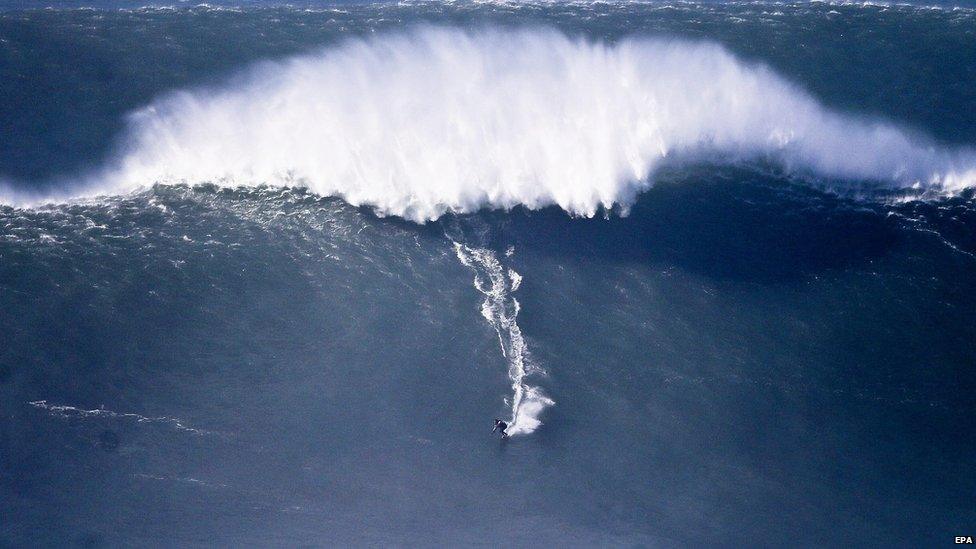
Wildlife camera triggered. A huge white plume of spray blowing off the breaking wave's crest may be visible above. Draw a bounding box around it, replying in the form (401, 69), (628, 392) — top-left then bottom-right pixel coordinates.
(98, 28), (976, 221)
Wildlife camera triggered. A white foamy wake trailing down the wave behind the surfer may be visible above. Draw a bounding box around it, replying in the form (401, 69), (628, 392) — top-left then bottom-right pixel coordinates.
(454, 242), (555, 436)
